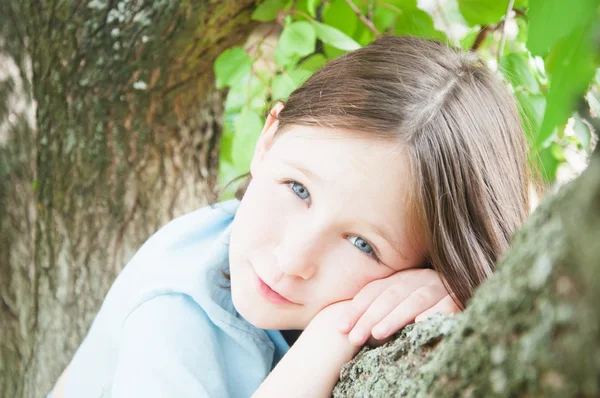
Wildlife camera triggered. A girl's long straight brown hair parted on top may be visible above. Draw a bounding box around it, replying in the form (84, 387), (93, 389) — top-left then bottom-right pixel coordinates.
(225, 37), (531, 306)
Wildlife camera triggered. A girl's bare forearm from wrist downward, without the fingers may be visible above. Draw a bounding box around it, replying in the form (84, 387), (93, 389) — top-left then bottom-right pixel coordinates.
(252, 301), (360, 398)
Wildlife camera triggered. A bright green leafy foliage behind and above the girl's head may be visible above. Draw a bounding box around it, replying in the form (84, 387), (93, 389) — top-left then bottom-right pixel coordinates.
(214, 0), (600, 199)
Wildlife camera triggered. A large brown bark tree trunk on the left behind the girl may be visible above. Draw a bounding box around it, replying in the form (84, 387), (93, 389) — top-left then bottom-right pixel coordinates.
(0, 0), (260, 397)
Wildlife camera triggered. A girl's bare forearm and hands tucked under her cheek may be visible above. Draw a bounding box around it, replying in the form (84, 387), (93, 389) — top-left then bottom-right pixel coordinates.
(253, 269), (459, 398)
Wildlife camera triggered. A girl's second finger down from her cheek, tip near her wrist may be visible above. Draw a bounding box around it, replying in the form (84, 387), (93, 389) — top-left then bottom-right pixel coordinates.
(348, 285), (410, 345)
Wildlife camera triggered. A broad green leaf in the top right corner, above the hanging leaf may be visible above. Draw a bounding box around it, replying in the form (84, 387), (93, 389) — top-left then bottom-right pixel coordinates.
(527, 0), (600, 56)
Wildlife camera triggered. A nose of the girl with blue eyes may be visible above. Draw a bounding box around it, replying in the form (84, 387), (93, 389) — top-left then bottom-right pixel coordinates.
(274, 225), (326, 280)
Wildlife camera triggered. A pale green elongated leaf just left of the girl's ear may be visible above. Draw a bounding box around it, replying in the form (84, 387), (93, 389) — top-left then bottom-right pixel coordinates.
(231, 109), (264, 173)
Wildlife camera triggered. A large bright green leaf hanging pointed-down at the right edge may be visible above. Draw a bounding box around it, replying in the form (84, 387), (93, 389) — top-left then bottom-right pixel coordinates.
(536, 24), (596, 146)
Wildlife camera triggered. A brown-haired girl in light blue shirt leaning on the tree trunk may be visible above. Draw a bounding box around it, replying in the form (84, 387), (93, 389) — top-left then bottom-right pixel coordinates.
(53, 37), (529, 398)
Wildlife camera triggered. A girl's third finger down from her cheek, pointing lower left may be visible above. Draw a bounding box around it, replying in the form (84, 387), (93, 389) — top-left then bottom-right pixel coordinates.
(372, 284), (448, 339)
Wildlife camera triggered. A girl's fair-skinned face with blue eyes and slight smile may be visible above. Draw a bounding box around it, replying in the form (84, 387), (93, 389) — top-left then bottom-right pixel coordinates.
(229, 107), (424, 330)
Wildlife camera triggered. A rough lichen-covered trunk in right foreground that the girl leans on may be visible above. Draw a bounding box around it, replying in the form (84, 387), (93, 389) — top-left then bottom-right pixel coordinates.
(334, 150), (600, 398)
